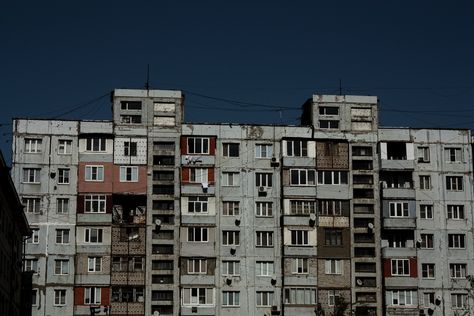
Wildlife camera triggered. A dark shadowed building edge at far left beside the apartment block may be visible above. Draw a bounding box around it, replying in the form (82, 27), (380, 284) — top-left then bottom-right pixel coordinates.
(0, 152), (32, 316)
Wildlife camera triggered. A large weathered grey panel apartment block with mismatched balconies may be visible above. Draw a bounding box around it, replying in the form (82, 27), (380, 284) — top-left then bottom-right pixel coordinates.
(13, 89), (474, 316)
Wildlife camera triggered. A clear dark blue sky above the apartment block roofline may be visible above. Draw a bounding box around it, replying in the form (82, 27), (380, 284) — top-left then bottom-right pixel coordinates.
(0, 0), (474, 163)
